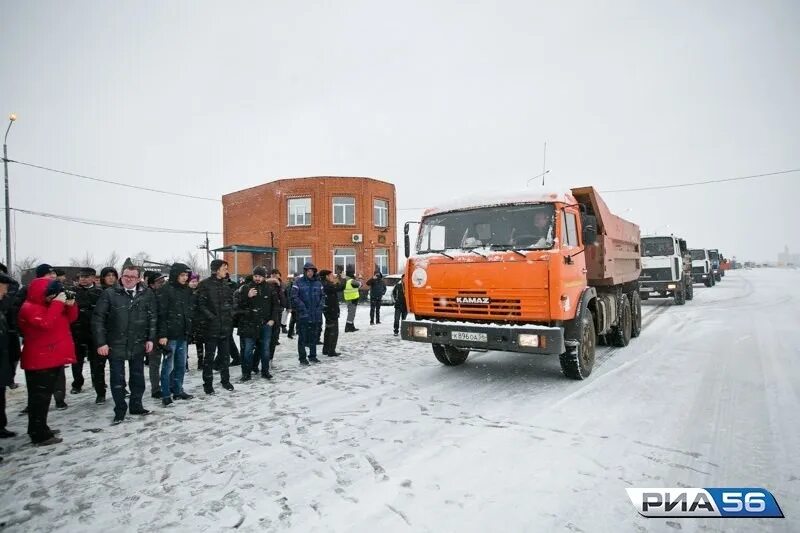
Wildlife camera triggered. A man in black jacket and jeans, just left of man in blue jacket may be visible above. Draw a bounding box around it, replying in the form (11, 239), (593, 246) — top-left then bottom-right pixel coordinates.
(236, 266), (281, 383)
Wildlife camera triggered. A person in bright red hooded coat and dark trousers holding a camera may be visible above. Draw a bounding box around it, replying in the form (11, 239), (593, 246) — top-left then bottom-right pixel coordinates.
(19, 278), (78, 446)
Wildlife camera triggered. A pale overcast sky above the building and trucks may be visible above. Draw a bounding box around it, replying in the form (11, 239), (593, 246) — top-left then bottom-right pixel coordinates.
(0, 0), (800, 264)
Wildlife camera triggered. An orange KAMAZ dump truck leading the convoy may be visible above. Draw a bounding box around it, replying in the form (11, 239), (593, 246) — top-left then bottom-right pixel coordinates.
(401, 187), (641, 379)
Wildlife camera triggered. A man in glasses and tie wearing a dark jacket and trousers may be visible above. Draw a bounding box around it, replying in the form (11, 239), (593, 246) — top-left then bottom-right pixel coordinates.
(92, 266), (158, 425)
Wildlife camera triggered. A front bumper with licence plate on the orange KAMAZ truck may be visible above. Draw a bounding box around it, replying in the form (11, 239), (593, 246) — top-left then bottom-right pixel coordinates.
(400, 320), (566, 355)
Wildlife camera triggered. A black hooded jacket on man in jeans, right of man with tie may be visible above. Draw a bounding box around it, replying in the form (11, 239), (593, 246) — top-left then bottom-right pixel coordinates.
(158, 263), (194, 341)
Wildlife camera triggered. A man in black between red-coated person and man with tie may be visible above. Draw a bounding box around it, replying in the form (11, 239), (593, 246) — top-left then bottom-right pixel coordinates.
(70, 267), (106, 403)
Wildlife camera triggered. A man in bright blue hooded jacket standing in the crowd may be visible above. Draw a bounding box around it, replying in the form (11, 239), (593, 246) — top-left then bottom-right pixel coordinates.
(292, 263), (324, 365)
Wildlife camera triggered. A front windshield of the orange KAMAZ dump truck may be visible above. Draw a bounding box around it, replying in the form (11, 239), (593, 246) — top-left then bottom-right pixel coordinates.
(417, 204), (555, 253)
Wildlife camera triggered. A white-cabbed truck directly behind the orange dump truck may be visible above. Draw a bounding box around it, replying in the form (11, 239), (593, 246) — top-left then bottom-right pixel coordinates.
(639, 235), (694, 305)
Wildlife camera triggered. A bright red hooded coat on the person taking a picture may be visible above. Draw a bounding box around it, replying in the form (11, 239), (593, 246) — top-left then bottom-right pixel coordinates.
(19, 278), (78, 370)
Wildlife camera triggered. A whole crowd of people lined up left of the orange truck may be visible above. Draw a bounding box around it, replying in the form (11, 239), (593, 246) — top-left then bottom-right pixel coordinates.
(0, 259), (407, 461)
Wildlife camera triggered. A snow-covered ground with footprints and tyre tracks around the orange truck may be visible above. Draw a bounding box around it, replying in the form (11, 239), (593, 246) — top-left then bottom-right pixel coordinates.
(0, 269), (800, 532)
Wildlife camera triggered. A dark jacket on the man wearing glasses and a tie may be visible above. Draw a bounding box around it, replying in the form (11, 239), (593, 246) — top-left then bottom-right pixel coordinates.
(92, 283), (158, 359)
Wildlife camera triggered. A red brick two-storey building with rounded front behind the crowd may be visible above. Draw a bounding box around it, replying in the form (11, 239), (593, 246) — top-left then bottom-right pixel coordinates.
(222, 176), (397, 277)
